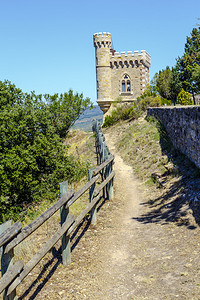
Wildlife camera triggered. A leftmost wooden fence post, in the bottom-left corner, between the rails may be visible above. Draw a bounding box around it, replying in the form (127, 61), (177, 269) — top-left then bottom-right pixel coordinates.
(0, 220), (17, 300)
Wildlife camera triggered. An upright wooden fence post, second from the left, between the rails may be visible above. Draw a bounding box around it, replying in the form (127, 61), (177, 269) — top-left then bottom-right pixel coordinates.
(59, 181), (71, 266)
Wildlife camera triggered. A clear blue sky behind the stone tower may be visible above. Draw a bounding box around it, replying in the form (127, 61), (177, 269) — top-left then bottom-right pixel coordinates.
(0, 0), (200, 102)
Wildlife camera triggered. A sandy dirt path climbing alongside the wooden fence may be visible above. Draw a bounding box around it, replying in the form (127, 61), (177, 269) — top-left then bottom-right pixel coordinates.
(18, 134), (200, 300)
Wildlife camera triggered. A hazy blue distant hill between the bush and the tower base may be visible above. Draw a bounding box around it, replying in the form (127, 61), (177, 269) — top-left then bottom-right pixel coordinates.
(72, 105), (103, 131)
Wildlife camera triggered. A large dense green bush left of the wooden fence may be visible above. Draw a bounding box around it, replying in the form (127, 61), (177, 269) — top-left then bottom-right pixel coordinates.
(0, 81), (90, 222)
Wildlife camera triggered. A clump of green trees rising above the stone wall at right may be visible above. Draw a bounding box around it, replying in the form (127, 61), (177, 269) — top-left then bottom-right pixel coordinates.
(153, 26), (200, 105)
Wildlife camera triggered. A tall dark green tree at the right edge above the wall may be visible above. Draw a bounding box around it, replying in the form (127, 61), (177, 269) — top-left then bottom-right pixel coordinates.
(176, 27), (200, 104)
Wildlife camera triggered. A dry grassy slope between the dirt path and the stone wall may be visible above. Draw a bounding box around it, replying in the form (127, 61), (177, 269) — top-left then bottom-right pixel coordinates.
(106, 116), (200, 226)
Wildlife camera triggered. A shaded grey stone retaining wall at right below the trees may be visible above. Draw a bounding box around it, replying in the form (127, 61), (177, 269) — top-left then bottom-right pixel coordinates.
(147, 106), (200, 168)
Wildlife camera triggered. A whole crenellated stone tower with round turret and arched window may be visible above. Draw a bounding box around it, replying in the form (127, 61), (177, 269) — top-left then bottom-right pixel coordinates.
(93, 32), (151, 113)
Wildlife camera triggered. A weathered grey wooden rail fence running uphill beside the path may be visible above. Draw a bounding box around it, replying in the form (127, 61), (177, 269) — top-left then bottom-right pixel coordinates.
(0, 121), (115, 300)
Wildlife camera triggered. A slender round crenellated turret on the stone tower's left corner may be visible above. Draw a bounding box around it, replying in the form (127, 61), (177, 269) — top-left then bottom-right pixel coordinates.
(93, 32), (112, 112)
